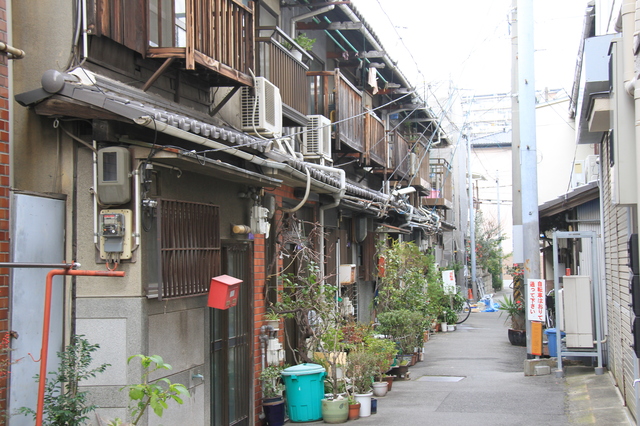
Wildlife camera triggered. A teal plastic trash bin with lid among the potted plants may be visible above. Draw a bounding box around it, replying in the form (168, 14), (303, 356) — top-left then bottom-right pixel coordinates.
(282, 363), (327, 422)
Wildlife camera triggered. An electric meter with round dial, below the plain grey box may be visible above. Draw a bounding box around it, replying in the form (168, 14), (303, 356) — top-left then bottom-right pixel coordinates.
(99, 210), (132, 262)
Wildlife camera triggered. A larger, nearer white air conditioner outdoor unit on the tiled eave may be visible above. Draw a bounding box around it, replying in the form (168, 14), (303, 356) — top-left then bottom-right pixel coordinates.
(240, 77), (282, 136)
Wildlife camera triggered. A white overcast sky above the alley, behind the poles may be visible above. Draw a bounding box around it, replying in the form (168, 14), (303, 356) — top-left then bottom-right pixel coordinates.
(352, 0), (587, 94)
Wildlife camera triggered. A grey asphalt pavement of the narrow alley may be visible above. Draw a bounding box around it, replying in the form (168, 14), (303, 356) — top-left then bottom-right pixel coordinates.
(349, 295), (635, 426)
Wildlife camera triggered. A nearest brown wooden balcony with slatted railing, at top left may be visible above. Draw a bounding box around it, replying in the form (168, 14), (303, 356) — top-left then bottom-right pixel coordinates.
(87, 0), (255, 90)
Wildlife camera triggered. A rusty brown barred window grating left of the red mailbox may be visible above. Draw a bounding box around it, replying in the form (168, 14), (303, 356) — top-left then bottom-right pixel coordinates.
(157, 200), (220, 299)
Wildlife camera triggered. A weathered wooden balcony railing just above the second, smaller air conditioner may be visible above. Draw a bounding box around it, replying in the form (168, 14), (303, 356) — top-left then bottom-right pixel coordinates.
(307, 69), (366, 154)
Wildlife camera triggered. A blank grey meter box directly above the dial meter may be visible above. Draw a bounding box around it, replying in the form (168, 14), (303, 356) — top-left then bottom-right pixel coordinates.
(97, 146), (131, 205)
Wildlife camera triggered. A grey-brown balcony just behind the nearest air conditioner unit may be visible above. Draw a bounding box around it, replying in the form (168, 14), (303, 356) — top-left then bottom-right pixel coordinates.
(256, 27), (311, 121)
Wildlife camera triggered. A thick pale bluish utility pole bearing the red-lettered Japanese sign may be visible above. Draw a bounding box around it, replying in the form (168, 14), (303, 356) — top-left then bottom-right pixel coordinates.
(517, 0), (541, 354)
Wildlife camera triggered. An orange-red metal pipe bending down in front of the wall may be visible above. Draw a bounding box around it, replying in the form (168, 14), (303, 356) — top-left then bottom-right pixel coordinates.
(36, 269), (124, 426)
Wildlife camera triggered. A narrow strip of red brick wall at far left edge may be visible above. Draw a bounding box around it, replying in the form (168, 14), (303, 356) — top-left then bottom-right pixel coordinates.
(0, 0), (10, 424)
